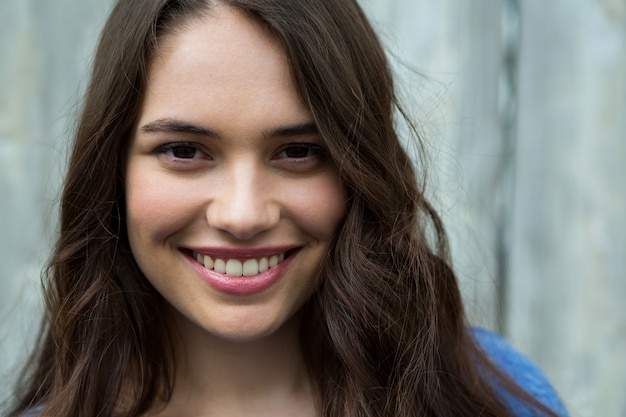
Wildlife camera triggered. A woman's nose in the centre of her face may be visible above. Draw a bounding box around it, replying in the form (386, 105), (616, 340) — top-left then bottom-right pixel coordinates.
(206, 163), (280, 240)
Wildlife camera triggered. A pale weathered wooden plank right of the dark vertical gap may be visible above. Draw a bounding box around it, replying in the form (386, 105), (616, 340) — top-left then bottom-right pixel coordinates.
(507, 0), (626, 417)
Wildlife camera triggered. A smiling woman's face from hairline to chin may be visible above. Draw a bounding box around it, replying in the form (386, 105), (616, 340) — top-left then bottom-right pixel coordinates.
(126, 7), (345, 341)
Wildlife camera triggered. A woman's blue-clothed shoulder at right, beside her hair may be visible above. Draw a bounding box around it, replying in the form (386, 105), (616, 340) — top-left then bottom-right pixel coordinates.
(472, 328), (568, 417)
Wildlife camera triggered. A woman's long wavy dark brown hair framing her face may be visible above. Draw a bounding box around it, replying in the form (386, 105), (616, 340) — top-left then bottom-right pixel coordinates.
(11, 0), (552, 417)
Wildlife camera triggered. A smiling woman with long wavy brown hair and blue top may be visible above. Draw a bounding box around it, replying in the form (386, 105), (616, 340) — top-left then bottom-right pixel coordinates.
(11, 0), (564, 417)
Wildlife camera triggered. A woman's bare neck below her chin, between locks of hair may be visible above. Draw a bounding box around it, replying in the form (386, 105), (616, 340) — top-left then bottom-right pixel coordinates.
(151, 308), (315, 416)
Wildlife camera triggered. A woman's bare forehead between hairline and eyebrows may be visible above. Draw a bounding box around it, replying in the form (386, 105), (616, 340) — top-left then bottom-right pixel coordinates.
(142, 6), (310, 131)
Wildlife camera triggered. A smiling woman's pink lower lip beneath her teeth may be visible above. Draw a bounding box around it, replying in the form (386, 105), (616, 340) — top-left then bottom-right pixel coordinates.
(187, 250), (295, 296)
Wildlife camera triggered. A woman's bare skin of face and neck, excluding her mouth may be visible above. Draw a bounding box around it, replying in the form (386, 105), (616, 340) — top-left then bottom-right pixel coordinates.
(126, 7), (345, 416)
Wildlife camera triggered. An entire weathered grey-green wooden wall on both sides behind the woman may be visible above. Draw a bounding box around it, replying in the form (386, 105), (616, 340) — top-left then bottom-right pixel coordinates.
(0, 0), (626, 417)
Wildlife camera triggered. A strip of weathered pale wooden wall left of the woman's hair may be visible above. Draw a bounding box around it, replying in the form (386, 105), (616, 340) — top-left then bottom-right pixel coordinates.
(0, 0), (111, 404)
